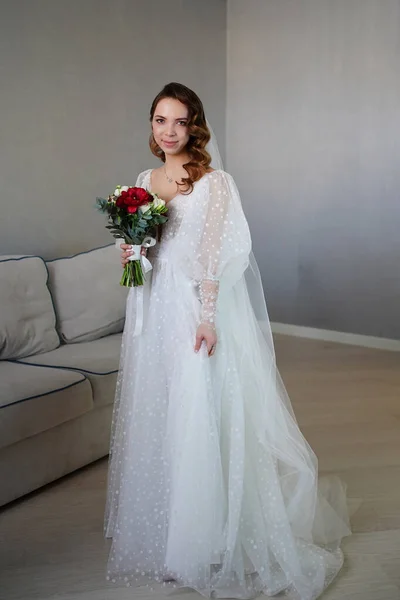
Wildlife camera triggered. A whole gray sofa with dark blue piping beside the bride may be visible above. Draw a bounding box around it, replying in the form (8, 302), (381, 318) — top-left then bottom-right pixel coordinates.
(0, 244), (127, 506)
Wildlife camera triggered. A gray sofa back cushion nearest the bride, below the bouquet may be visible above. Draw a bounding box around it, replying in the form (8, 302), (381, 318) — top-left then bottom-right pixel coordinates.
(47, 244), (128, 343)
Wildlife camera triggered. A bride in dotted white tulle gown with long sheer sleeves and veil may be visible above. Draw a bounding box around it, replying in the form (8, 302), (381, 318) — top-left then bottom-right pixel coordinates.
(105, 83), (351, 600)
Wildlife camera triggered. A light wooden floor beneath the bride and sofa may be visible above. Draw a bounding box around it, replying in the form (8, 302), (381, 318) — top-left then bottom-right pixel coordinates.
(0, 336), (400, 600)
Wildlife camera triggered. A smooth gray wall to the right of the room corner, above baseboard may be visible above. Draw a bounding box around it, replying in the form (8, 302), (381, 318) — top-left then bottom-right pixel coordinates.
(227, 0), (400, 338)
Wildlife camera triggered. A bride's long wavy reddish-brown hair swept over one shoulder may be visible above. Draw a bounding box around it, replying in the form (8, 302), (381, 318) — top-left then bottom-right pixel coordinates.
(149, 82), (211, 193)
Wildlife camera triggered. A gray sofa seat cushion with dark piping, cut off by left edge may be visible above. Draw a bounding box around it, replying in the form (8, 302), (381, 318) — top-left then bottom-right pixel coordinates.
(0, 361), (93, 448)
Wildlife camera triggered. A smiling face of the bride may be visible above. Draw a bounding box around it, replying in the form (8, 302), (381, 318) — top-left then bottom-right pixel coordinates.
(151, 98), (189, 155)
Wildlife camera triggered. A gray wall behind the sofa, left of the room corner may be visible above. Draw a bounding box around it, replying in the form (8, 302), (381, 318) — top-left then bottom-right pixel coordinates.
(0, 0), (226, 258)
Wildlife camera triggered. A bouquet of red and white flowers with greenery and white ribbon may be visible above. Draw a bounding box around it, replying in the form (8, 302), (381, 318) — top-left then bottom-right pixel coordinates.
(96, 185), (168, 287)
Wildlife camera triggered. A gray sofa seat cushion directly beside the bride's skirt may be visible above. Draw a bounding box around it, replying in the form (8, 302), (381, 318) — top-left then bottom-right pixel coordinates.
(18, 333), (122, 406)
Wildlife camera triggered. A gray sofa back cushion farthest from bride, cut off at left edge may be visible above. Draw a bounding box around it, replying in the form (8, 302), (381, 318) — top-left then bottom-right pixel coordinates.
(0, 256), (60, 360)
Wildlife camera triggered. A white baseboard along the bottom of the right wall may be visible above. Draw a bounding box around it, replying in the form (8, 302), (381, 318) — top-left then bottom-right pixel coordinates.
(271, 323), (400, 352)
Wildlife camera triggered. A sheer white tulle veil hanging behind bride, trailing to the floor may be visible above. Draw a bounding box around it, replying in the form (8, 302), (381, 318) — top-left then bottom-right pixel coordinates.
(202, 121), (351, 598)
